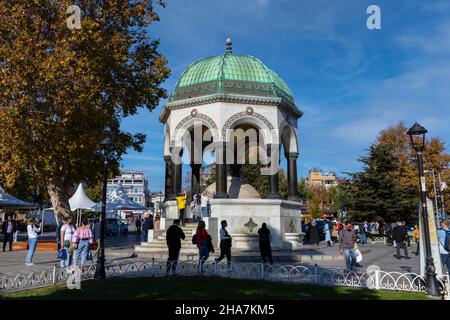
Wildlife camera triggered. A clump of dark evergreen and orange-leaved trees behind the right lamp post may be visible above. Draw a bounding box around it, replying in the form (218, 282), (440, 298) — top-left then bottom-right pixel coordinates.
(352, 122), (450, 220)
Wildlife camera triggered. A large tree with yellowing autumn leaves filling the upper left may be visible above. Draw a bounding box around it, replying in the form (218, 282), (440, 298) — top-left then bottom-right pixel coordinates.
(0, 0), (169, 218)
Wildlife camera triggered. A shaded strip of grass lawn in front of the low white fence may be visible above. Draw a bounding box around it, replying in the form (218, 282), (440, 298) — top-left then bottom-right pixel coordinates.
(1, 277), (427, 300)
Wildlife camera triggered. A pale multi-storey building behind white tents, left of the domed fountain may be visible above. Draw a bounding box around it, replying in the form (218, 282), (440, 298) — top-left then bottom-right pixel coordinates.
(107, 171), (151, 207)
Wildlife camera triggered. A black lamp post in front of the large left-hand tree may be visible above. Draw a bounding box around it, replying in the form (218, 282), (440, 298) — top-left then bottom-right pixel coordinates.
(94, 137), (111, 280)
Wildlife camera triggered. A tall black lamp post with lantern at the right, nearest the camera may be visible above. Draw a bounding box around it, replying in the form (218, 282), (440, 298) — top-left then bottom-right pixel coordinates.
(407, 122), (441, 296)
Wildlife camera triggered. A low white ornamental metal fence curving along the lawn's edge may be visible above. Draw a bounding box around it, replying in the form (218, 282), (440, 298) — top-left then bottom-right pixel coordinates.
(0, 260), (450, 299)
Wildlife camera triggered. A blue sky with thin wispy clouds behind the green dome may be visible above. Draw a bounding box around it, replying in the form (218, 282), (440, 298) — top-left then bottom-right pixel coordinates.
(118, 0), (450, 191)
